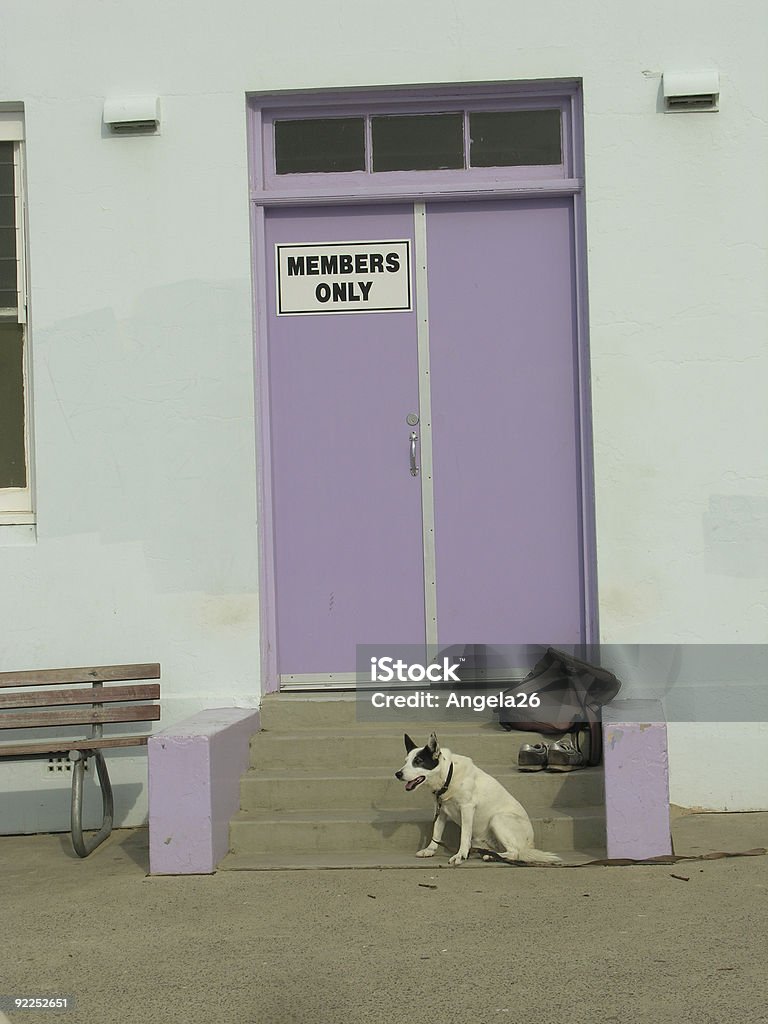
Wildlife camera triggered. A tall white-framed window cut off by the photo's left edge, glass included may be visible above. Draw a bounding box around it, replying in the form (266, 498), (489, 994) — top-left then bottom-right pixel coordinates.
(0, 111), (32, 523)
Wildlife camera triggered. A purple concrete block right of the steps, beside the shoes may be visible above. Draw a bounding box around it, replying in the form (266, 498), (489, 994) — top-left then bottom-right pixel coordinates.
(603, 700), (672, 860)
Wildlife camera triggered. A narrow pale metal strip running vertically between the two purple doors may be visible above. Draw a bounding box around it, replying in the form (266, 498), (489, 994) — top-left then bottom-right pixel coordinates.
(414, 203), (437, 647)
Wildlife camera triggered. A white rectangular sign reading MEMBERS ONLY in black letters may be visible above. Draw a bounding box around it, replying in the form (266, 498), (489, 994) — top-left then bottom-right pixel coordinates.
(274, 241), (412, 316)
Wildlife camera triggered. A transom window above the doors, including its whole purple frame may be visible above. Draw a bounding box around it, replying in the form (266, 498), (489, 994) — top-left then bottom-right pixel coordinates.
(248, 81), (584, 195)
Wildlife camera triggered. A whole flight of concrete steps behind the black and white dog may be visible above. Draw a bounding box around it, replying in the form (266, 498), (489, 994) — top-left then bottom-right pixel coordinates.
(219, 694), (605, 869)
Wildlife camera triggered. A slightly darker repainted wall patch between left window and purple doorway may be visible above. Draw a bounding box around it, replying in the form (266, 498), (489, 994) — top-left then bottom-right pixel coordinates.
(33, 279), (257, 594)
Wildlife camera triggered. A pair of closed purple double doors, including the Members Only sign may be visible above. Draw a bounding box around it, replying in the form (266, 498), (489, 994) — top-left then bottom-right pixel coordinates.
(266, 198), (588, 685)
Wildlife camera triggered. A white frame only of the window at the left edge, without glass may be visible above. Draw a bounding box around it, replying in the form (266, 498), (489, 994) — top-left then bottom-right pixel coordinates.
(0, 108), (35, 526)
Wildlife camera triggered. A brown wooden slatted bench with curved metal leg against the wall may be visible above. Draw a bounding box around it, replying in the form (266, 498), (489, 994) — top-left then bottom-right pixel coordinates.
(0, 665), (160, 857)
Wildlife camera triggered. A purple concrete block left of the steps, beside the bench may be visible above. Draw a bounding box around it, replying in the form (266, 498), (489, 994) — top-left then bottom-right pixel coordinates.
(147, 708), (260, 874)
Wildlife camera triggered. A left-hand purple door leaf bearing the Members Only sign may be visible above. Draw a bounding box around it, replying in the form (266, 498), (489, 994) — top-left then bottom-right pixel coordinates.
(266, 206), (424, 683)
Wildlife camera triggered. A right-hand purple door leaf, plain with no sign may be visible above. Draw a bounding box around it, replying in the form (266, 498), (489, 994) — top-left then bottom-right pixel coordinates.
(427, 199), (587, 645)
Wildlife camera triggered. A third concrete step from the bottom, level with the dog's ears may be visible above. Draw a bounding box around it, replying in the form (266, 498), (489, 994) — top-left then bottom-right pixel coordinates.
(250, 724), (553, 772)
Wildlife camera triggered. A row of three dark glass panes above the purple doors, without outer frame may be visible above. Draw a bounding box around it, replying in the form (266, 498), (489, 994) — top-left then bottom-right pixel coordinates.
(273, 108), (562, 175)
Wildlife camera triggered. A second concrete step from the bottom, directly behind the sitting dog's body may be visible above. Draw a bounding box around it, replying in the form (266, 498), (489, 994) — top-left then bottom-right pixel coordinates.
(240, 764), (603, 811)
